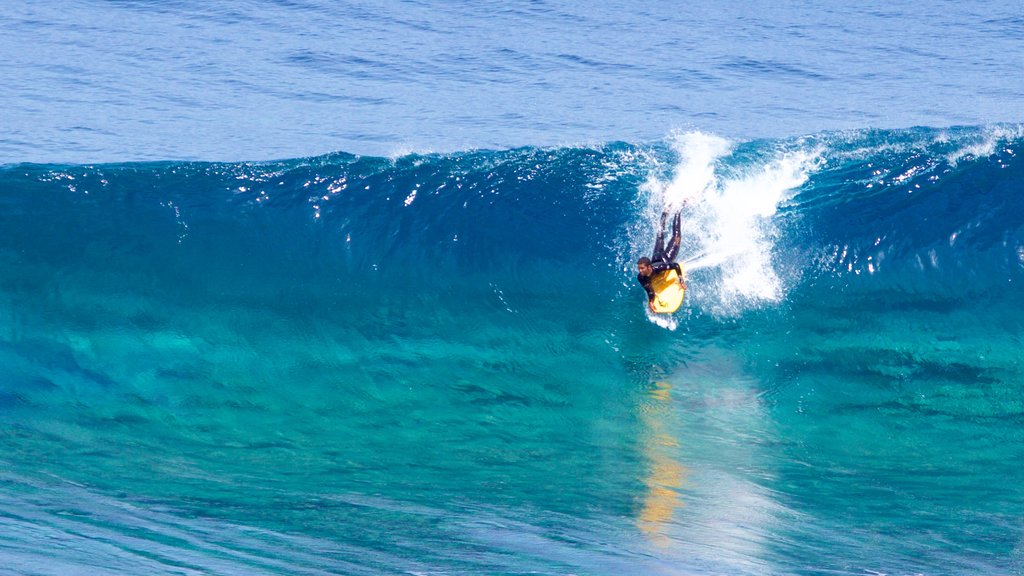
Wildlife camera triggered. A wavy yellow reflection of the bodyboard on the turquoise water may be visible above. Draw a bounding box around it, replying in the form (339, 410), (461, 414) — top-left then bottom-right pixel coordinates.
(637, 382), (686, 545)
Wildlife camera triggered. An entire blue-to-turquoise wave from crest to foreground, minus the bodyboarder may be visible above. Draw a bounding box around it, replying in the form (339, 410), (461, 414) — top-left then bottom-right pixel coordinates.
(0, 126), (1024, 574)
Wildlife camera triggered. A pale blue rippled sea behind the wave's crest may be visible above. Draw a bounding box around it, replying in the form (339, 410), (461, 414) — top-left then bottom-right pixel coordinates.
(0, 0), (1024, 163)
